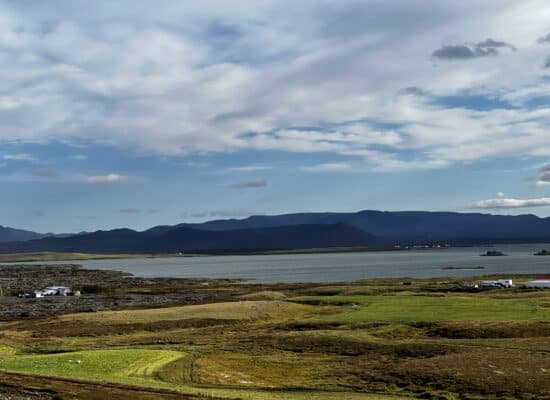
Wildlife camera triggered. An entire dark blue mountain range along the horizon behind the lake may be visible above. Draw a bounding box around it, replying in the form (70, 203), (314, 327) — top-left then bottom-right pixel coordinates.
(0, 210), (550, 253)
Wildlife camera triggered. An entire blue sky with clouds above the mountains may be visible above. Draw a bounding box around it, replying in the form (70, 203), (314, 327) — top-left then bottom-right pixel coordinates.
(0, 0), (550, 232)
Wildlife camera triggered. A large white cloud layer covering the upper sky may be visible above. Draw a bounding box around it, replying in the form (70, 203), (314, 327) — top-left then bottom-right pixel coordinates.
(0, 0), (550, 171)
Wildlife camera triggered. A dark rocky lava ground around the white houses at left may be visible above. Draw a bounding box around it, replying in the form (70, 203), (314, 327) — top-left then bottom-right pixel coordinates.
(0, 265), (242, 320)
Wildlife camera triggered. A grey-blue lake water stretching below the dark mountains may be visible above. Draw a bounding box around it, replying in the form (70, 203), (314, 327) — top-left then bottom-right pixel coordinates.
(11, 244), (550, 282)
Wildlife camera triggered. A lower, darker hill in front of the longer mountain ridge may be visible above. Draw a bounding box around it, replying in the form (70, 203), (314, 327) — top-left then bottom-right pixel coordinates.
(0, 224), (377, 253)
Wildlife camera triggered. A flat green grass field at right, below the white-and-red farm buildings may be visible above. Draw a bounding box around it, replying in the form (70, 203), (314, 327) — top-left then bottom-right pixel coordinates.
(300, 295), (550, 323)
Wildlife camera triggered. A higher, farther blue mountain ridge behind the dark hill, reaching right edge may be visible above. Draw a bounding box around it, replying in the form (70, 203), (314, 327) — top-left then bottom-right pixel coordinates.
(183, 211), (550, 242)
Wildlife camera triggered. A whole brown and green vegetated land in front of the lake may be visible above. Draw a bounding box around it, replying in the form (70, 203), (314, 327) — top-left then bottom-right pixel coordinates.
(0, 266), (550, 400)
